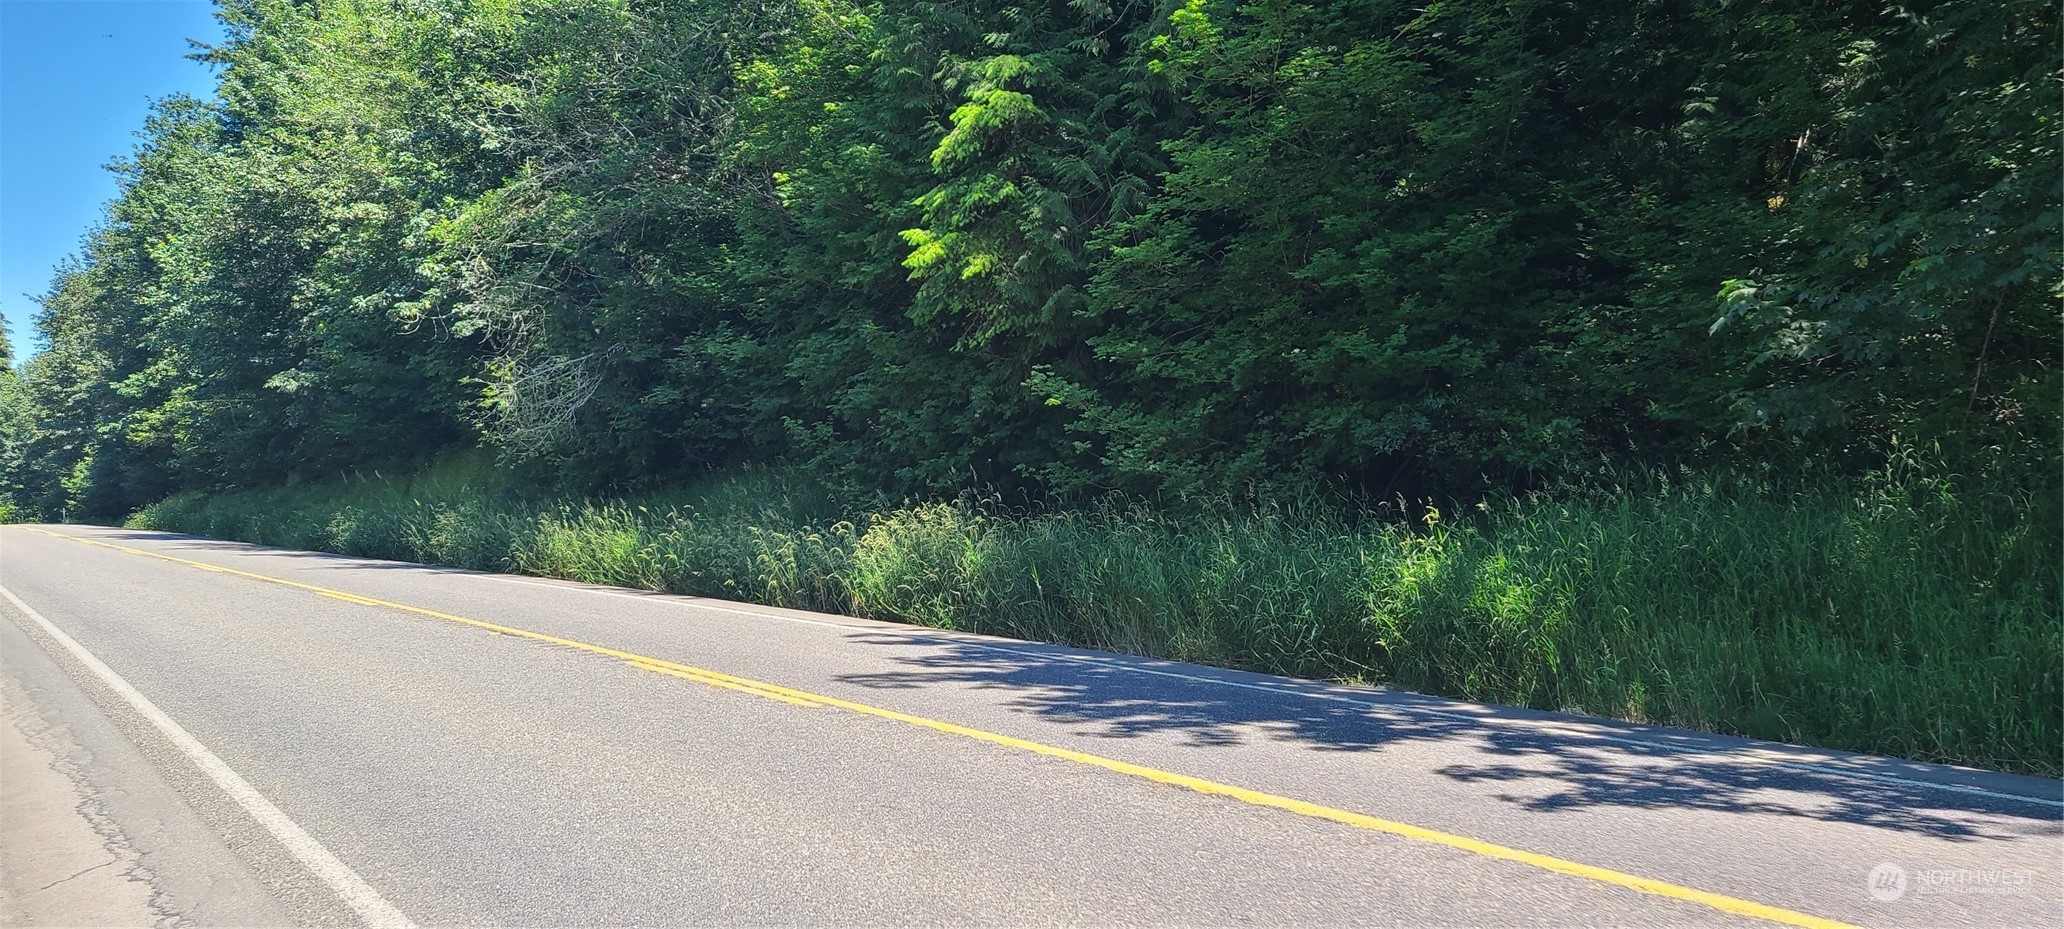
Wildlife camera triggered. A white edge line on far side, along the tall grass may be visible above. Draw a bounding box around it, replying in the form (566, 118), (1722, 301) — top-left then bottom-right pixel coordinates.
(464, 572), (2064, 809)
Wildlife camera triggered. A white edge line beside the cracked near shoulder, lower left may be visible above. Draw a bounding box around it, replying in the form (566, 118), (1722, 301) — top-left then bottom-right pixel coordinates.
(0, 586), (415, 929)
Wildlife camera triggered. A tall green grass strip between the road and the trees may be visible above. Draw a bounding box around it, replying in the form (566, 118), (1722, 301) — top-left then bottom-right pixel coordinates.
(130, 458), (2064, 776)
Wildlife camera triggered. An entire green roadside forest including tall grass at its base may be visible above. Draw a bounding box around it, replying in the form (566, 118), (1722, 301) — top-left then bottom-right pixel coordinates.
(0, 0), (2064, 772)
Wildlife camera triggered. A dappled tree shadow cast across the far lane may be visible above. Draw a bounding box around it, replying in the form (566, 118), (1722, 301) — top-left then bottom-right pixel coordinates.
(838, 634), (2064, 840)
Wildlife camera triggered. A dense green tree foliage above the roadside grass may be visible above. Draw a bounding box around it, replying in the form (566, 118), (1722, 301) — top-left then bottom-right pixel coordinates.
(0, 0), (2064, 516)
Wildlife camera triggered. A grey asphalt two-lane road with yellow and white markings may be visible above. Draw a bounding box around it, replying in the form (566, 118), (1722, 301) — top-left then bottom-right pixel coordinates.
(0, 526), (2064, 927)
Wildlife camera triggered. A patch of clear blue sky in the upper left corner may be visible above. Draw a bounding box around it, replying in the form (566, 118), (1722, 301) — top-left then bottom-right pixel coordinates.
(0, 0), (223, 353)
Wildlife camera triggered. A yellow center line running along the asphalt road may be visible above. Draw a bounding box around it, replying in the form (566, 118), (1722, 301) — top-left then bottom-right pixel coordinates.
(23, 526), (1853, 929)
